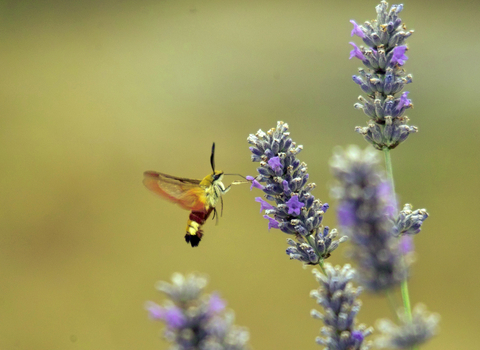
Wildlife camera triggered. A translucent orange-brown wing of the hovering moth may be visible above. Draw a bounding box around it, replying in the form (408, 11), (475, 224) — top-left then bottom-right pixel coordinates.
(143, 171), (206, 210)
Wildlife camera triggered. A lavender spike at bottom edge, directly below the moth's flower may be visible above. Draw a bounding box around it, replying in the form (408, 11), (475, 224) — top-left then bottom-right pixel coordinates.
(310, 264), (373, 350)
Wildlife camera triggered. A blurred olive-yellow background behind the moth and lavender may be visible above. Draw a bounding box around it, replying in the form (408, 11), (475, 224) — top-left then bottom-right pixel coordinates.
(0, 0), (480, 350)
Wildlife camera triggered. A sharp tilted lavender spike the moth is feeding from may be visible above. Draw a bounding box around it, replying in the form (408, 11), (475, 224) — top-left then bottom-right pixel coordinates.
(247, 122), (346, 265)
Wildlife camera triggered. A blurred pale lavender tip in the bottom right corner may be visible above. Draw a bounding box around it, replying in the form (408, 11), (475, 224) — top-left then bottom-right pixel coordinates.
(375, 304), (440, 349)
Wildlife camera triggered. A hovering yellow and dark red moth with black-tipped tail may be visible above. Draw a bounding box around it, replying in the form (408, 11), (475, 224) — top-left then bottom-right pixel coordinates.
(143, 142), (243, 247)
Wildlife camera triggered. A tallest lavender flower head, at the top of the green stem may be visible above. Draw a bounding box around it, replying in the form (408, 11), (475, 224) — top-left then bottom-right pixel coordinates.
(350, 1), (418, 150)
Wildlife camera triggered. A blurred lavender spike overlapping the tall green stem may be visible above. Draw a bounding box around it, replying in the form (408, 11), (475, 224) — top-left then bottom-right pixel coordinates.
(330, 146), (407, 292)
